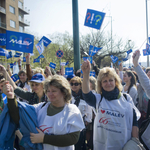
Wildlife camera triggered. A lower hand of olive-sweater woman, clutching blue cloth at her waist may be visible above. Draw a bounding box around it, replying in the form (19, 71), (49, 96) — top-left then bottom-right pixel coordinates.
(30, 128), (44, 143)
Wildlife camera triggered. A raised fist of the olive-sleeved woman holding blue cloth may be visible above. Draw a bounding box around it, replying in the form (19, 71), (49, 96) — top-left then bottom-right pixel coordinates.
(2, 81), (14, 99)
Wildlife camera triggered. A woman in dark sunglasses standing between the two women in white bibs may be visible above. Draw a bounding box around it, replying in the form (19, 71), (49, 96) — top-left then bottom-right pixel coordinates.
(70, 76), (92, 150)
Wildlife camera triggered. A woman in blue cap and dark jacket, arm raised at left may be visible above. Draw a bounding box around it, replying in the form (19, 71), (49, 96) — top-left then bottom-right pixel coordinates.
(0, 65), (48, 104)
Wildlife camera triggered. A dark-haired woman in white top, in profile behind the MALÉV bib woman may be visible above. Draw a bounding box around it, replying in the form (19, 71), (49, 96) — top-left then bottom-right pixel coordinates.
(122, 70), (138, 105)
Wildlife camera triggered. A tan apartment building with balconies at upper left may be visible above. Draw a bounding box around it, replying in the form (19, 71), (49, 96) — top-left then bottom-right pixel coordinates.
(0, 0), (30, 33)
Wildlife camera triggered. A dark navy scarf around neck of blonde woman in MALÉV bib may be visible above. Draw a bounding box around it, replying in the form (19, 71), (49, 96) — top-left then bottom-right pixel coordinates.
(102, 87), (120, 101)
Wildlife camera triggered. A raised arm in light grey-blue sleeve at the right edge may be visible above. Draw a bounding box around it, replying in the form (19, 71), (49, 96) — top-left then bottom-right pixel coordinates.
(132, 50), (150, 98)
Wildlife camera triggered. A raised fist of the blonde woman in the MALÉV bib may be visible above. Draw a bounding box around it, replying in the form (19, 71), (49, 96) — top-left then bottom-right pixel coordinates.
(81, 60), (91, 75)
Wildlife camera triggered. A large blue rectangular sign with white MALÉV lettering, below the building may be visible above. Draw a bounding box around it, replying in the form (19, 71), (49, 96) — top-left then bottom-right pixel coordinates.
(6, 30), (34, 53)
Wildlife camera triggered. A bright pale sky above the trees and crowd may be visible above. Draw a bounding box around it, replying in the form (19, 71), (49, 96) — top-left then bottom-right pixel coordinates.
(24, 0), (150, 64)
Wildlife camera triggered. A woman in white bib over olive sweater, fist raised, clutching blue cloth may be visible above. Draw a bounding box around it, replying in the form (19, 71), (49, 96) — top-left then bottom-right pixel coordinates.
(3, 75), (85, 150)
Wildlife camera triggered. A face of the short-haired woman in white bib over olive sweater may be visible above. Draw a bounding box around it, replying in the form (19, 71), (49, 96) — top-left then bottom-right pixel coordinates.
(46, 86), (65, 107)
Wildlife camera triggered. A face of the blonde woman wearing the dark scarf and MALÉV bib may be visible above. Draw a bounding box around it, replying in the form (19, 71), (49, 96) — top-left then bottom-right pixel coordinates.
(101, 77), (116, 92)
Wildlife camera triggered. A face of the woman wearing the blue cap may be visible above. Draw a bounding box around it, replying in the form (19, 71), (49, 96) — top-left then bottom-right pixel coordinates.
(31, 82), (44, 94)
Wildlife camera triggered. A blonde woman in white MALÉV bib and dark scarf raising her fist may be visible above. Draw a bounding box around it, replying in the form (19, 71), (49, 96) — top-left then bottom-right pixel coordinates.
(81, 61), (140, 150)
